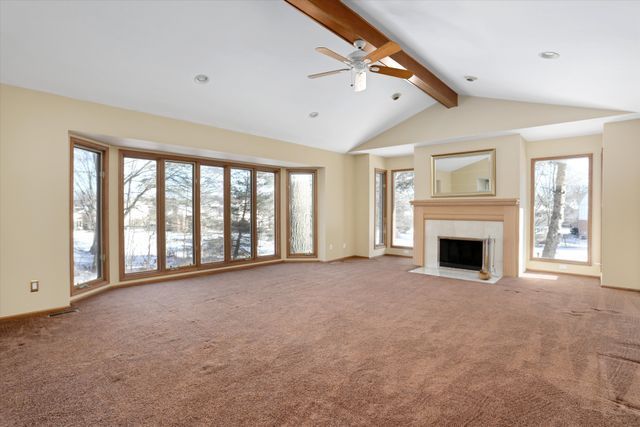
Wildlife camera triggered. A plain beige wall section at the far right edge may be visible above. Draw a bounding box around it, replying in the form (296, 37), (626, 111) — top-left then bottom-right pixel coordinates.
(602, 120), (640, 290)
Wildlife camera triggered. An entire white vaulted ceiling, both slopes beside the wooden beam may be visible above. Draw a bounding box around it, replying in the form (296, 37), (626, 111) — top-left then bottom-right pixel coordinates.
(0, 0), (640, 152)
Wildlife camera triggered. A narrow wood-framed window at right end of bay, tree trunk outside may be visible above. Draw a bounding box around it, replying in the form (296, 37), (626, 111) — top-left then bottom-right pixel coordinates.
(287, 170), (317, 257)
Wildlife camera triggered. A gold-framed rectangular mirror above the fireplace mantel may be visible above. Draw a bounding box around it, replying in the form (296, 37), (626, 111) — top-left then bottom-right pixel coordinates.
(431, 149), (496, 197)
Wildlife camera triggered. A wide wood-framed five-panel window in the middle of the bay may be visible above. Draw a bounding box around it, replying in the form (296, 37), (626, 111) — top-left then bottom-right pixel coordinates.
(120, 150), (280, 280)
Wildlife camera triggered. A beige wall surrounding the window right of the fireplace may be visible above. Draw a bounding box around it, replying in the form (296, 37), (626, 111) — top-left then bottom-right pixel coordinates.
(524, 135), (602, 277)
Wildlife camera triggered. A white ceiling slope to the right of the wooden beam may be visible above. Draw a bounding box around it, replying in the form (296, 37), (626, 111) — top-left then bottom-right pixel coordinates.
(345, 0), (640, 112)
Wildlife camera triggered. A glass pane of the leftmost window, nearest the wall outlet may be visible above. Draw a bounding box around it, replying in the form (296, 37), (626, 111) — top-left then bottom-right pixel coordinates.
(73, 147), (102, 286)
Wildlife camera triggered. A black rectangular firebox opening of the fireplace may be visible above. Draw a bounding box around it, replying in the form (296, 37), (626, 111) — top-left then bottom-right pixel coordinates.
(438, 236), (487, 271)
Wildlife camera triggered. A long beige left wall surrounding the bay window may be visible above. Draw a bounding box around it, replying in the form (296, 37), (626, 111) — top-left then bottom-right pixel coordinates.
(0, 85), (356, 316)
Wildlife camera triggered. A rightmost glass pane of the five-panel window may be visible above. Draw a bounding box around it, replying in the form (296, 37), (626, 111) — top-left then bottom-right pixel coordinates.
(256, 171), (276, 256)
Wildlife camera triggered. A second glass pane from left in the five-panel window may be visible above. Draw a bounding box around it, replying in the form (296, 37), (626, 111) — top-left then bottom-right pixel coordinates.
(164, 162), (195, 268)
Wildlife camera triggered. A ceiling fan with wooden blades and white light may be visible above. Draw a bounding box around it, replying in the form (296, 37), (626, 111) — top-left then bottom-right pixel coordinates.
(308, 40), (413, 92)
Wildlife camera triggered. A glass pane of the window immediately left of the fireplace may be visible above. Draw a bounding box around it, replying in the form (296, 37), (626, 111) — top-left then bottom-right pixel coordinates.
(391, 171), (413, 247)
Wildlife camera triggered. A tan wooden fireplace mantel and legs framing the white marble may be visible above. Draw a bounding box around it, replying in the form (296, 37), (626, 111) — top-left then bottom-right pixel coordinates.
(411, 198), (519, 277)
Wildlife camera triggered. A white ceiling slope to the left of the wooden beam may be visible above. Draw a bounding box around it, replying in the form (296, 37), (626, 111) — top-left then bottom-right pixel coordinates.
(0, 0), (434, 152)
